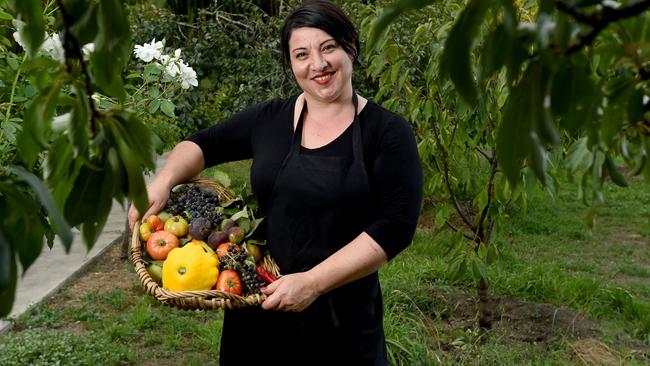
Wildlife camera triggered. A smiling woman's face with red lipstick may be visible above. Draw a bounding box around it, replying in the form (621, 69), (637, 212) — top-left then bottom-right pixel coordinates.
(289, 27), (352, 102)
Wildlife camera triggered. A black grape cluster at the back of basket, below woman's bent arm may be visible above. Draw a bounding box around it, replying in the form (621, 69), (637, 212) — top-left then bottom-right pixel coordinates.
(165, 184), (223, 227)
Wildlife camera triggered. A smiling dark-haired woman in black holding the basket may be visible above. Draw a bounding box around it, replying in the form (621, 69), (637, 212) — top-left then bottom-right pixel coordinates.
(129, 0), (422, 365)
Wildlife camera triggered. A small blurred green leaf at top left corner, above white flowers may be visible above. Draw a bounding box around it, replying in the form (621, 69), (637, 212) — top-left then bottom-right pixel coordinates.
(9, 0), (45, 58)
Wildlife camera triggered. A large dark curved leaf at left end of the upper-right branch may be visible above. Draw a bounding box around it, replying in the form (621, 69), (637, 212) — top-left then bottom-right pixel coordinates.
(440, 0), (492, 106)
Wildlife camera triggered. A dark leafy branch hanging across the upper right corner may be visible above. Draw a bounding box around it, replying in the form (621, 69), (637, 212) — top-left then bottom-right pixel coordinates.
(369, 0), (650, 191)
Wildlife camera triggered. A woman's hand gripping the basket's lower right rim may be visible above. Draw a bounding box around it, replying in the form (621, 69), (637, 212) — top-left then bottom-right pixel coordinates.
(262, 272), (320, 312)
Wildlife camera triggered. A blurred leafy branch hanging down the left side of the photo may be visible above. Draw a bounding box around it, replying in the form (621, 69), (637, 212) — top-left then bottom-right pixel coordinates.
(0, 0), (155, 316)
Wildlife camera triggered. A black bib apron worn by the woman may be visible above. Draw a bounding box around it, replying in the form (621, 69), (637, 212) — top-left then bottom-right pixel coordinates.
(220, 93), (387, 365)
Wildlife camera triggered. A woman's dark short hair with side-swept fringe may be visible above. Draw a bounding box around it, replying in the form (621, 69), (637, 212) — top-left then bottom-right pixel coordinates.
(280, 0), (360, 70)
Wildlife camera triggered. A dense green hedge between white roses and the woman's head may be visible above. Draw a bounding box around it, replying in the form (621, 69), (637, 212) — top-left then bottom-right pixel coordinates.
(129, 4), (296, 137)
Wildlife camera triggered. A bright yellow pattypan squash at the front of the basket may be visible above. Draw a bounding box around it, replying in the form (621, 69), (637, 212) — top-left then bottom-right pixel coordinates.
(163, 243), (219, 291)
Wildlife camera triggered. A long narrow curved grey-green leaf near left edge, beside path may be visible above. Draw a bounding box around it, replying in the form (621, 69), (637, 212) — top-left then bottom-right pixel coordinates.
(10, 167), (73, 250)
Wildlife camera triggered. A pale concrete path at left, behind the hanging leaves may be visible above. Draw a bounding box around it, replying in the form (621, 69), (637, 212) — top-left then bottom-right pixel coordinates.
(0, 157), (164, 333)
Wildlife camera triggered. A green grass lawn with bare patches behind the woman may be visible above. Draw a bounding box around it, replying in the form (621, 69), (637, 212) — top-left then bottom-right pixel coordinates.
(0, 163), (650, 366)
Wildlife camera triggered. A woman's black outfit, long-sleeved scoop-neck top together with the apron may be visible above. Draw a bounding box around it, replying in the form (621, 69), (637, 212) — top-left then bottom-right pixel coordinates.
(188, 97), (422, 365)
